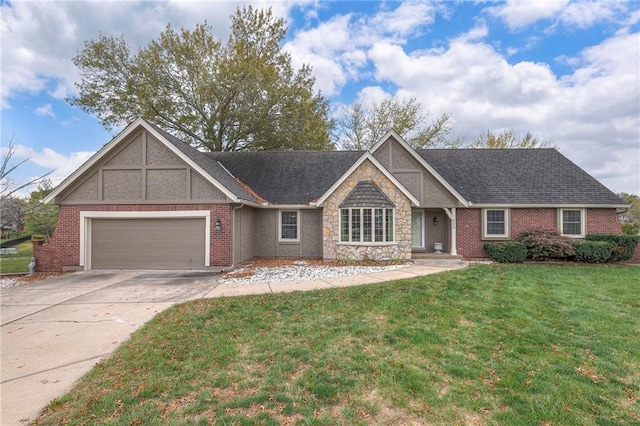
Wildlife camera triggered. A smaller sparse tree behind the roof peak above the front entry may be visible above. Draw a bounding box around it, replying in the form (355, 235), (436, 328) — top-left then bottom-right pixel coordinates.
(336, 97), (459, 150)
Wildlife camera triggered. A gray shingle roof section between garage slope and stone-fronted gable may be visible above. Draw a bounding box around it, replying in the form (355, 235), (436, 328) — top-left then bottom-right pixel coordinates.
(206, 151), (364, 204)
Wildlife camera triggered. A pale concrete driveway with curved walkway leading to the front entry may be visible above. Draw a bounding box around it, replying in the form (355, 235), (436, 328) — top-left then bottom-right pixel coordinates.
(0, 260), (467, 426)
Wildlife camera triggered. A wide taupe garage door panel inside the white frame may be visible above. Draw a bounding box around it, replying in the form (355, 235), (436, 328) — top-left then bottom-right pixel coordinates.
(91, 218), (206, 269)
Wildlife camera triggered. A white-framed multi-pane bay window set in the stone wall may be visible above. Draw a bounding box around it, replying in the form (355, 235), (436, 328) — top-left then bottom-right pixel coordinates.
(340, 208), (394, 243)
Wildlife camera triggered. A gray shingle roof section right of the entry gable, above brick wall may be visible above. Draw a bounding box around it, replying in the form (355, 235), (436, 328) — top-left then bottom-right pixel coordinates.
(417, 148), (625, 205)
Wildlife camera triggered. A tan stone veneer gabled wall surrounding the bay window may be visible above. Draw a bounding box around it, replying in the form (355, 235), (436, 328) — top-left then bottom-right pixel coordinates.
(322, 160), (411, 260)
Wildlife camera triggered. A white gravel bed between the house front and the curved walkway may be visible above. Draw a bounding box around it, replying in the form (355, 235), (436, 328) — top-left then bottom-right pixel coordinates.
(219, 265), (406, 284)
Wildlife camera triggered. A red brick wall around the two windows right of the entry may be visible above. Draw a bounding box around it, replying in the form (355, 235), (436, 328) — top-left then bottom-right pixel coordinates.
(456, 208), (624, 258)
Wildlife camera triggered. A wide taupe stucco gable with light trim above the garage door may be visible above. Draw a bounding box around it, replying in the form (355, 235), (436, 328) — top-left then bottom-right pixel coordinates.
(45, 119), (248, 204)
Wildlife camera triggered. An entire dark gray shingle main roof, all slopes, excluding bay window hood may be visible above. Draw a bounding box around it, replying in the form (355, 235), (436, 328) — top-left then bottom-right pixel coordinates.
(153, 121), (625, 206)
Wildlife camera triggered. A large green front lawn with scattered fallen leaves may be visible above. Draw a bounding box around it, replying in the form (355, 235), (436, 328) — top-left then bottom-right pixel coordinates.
(36, 264), (640, 425)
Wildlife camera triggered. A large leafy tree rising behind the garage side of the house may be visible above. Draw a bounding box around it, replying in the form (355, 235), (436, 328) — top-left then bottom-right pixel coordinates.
(69, 6), (333, 151)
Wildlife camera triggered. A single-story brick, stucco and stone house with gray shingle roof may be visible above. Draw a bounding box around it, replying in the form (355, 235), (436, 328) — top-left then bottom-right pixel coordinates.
(34, 119), (626, 271)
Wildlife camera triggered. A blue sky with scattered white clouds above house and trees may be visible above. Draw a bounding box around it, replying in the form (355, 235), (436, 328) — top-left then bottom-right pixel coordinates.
(0, 0), (640, 194)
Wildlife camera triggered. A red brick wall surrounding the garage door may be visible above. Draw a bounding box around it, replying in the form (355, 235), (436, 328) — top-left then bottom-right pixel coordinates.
(33, 204), (231, 272)
